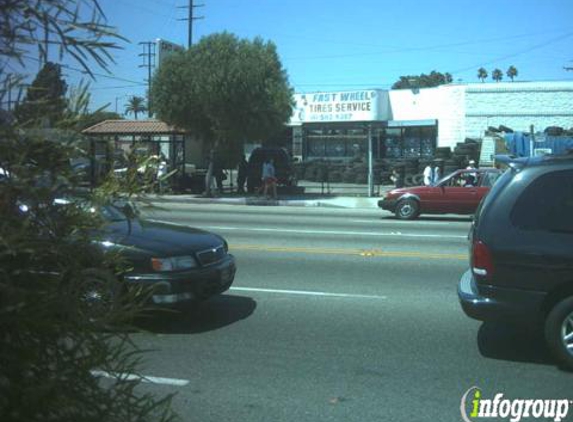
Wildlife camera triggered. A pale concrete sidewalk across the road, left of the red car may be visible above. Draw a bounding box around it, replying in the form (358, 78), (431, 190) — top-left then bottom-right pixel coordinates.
(148, 182), (393, 209)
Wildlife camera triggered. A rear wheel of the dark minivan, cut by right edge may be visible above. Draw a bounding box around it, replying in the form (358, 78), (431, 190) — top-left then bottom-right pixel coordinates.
(545, 297), (573, 370)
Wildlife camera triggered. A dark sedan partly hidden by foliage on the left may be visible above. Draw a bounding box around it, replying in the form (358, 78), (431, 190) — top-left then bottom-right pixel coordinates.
(13, 198), (236, 316)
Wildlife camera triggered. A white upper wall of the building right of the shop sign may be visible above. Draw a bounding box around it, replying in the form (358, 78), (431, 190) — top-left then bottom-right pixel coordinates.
(390, 81), (573, 148)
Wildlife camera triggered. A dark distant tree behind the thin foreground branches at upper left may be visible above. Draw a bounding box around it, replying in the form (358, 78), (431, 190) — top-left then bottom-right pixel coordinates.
(15, 62), (68, 127)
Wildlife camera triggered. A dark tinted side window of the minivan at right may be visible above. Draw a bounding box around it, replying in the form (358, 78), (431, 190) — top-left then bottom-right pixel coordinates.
(510, 170), (573, 234)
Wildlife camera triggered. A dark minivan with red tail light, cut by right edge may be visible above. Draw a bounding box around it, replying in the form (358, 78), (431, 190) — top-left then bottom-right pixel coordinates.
(458, 155), (573, 368)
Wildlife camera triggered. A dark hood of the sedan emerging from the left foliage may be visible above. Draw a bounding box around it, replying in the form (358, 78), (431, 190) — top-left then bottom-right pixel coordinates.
(98, 219), (224, 257)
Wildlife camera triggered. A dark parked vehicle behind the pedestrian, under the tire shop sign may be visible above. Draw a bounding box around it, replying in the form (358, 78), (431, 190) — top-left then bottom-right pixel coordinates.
(247, 147), (297, 193)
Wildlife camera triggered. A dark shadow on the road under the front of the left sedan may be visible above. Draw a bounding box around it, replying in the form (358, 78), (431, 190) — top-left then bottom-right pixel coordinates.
(136, 295), (257, 334)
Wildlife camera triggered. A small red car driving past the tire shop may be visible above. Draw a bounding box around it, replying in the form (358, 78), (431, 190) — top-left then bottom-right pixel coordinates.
(378, 168), (501, 220)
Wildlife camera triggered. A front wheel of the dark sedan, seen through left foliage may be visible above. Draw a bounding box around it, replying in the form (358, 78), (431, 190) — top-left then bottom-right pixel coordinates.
(75, 268), (119, 321)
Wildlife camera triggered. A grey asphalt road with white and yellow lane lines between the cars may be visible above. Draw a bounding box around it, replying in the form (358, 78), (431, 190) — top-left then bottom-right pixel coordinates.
(134, 204), (573, 422)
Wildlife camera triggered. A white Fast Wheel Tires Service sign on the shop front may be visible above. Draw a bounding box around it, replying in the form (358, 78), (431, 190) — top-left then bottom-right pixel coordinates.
(290, 90), (389, 124)
